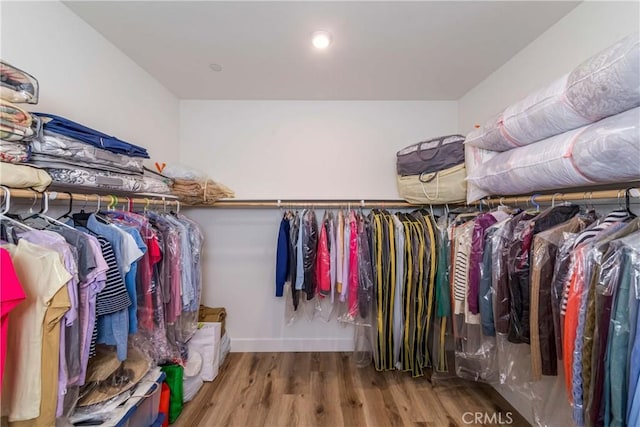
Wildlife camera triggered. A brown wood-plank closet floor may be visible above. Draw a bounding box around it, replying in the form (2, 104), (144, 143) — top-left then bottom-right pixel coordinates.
(173, 353), (529, 427)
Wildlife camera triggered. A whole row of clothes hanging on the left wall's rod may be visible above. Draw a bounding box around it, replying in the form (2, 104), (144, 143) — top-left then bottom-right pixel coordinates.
(0, 204), (202, 426)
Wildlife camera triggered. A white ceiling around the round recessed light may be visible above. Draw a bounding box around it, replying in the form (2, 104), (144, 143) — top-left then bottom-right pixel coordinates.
(66, 1), (579, 100)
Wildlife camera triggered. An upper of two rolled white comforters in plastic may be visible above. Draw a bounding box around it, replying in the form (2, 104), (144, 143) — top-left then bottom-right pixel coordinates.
(465, 33), (640, 151)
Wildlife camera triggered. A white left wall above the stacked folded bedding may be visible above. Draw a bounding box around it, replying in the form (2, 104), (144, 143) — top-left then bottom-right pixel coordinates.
(0, 1), (179, 165)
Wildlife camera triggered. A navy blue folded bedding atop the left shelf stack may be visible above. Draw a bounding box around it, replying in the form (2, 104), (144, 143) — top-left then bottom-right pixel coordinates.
(33, 113), (149, 159)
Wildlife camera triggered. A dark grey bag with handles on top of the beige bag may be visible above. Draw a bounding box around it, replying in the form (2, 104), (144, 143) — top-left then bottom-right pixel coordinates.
(396, 135), (464, 176)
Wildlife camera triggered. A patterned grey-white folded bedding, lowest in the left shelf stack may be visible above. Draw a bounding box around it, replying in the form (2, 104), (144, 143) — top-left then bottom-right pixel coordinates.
(47, 168), (171, 194)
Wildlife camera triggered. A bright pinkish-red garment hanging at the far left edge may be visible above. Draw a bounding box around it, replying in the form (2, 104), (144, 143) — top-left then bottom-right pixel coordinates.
(0, 248), (26, 390)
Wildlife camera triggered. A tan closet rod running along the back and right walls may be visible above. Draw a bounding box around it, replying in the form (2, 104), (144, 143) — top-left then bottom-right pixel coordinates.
(208, 188), (637, 209)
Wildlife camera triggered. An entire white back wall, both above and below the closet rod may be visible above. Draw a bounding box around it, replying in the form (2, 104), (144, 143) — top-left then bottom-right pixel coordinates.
(180, 101), (457, 351)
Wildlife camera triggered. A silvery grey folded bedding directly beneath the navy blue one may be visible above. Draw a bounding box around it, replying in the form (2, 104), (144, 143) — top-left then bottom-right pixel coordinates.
(31, 131), (144, 174)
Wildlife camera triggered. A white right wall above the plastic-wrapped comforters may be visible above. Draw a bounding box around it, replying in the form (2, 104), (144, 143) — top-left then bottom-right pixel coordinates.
(459, 1), (640, 134)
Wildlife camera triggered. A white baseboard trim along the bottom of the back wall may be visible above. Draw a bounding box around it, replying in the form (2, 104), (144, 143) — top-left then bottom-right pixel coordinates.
(231, 338), (353, 353)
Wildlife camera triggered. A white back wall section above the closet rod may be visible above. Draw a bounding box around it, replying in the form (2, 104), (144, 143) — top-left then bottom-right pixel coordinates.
(180, 101), (458, 199)
